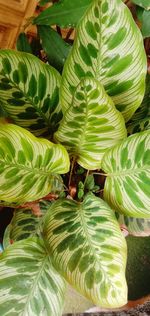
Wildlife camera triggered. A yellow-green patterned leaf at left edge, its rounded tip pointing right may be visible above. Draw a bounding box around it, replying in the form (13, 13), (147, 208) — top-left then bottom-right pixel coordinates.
(0, 124), (70, 205)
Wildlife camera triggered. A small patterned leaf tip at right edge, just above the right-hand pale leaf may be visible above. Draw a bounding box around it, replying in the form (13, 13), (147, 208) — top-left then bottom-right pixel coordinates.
(127, 116), (150, 135)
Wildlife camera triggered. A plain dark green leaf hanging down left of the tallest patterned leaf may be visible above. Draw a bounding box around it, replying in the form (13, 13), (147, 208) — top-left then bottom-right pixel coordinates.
(38, 25), (71, 72)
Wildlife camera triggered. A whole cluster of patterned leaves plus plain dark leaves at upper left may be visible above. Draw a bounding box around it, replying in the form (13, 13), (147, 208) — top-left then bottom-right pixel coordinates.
(0, 0), (150, 316)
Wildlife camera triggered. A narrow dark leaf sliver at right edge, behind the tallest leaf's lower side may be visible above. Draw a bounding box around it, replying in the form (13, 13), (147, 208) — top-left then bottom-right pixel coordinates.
(127, 75), (150, 126)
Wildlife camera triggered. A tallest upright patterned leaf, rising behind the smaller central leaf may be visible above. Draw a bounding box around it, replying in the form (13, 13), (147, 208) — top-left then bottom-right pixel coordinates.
(61, 0), (147, 121)
